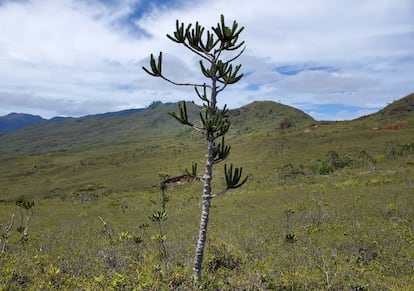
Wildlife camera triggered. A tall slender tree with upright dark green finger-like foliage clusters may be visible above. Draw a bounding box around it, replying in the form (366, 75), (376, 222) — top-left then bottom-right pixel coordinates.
(143, 15), (247, 281)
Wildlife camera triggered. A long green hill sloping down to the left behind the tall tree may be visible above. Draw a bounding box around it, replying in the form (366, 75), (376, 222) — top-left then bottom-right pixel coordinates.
(0, 102), (189, 154)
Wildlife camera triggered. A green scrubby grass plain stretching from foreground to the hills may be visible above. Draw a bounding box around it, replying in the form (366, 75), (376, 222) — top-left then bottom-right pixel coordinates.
(0, 99), (414, 290)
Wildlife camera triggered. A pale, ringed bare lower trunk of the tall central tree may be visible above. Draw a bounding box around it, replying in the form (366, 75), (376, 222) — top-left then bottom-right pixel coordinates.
(193, 136), (214, 282)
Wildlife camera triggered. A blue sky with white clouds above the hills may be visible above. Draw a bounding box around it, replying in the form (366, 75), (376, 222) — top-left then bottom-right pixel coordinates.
(0, 0), (414, 120)
